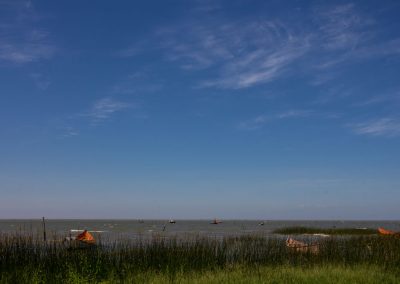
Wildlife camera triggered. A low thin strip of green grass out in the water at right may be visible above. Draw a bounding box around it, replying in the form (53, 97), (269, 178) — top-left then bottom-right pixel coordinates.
(273, 227), (378, 236)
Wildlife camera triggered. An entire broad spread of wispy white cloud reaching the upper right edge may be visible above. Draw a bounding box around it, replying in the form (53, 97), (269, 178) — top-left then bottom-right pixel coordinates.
(122, 2), (400, 95)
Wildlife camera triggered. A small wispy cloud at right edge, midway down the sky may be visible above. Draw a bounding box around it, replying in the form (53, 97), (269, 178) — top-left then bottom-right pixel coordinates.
(349, 117), (400, 137)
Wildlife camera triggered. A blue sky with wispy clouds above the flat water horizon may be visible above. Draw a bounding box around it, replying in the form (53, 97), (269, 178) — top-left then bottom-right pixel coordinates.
(0, 0), (400, 219)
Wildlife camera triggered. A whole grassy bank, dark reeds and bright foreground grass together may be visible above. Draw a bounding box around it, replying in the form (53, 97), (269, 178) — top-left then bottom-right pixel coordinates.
(0, 232), (400, 283)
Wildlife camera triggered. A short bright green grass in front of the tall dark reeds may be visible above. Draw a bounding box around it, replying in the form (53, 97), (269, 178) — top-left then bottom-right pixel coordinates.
(0, 265), (400, 284)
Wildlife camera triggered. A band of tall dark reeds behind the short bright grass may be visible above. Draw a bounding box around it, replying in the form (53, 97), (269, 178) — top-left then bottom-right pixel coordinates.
(0, 234), (400, 283)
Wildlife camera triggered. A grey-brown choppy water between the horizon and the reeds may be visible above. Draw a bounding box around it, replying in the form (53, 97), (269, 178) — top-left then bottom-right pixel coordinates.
(0, 219), (400, 239)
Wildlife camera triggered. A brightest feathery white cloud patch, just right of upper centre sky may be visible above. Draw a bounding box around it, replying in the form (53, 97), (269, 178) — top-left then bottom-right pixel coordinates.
(159, 21), (310, 89)
